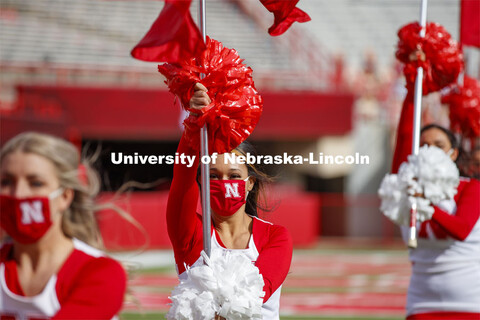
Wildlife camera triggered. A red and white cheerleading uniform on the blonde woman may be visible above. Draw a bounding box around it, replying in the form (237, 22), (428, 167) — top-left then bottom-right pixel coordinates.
(0, 239), (126, 320)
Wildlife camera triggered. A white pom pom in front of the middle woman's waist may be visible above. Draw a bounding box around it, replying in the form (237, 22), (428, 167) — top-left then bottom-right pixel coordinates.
(167, 250), (265, 320)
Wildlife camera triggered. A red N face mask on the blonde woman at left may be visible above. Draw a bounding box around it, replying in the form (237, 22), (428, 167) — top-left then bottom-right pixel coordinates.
(0, 188), (63, 244)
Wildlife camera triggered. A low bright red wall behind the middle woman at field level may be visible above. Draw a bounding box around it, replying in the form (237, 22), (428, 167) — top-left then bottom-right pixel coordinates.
(97, 188), (320, 250)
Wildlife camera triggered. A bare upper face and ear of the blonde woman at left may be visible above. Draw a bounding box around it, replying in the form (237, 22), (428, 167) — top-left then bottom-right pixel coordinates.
(0, 151), (73, 240)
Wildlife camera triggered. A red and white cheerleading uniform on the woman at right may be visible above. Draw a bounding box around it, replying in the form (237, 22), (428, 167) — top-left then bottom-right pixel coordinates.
(392, 93), (480, 320)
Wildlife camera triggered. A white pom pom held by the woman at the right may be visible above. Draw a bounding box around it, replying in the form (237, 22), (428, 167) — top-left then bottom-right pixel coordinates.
(378, 146), (459, 226)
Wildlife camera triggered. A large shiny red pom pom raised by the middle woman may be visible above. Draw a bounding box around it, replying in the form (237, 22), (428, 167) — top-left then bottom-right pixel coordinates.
(158, 37), (263, 153)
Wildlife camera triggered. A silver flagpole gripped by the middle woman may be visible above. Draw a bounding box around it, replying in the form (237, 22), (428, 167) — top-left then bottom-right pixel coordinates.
(198, 0), (212, 257)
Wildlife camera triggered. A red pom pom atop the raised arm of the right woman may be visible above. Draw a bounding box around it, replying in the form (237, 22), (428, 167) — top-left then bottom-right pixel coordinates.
(395, 22), (463, 95)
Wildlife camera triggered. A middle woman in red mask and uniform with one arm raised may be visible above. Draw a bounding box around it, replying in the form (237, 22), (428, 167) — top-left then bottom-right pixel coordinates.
(167, 83), (292, 320)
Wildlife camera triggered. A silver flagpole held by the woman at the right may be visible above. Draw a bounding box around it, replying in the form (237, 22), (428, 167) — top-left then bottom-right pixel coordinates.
(408, 0), (427, 248)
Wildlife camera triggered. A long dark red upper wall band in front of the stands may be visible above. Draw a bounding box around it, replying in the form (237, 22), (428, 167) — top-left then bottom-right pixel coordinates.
(0, 85), (353, 140)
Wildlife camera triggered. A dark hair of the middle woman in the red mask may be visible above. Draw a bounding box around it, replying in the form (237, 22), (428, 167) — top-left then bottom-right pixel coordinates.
(197, 141), (273, 217)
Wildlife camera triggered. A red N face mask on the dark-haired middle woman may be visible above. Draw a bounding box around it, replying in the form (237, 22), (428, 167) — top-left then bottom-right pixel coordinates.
(210, 177), (249, 217)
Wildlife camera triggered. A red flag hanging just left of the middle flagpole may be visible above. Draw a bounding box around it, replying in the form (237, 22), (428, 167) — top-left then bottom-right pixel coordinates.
(131, 0), (205, 63)
